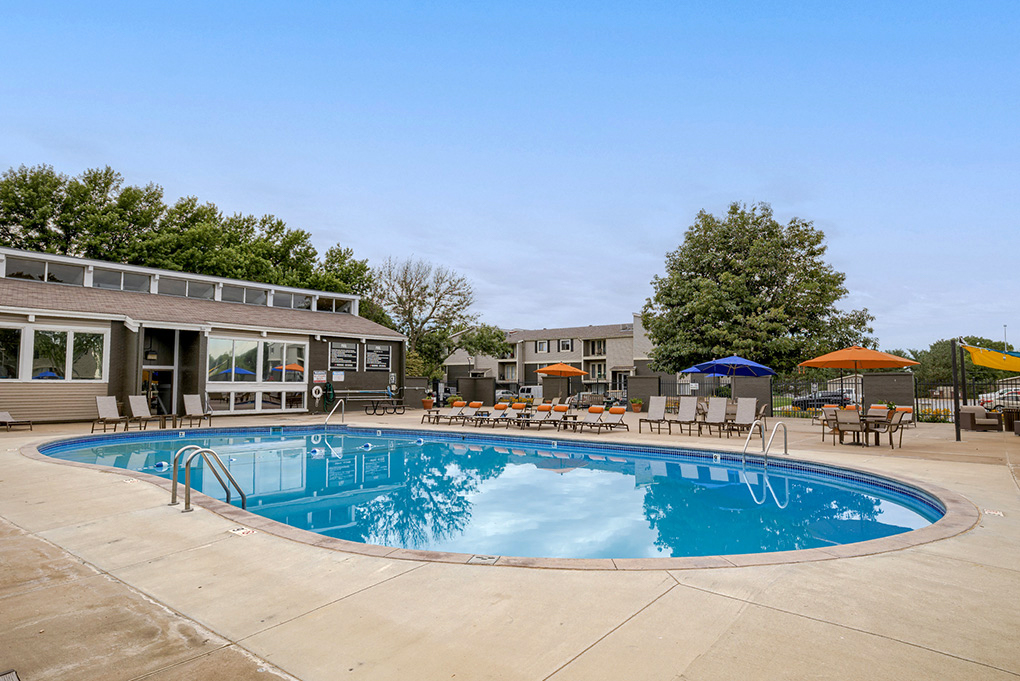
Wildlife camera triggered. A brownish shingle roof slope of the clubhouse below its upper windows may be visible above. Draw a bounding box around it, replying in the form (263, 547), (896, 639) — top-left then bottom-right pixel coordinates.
(0, 278), (404, 341)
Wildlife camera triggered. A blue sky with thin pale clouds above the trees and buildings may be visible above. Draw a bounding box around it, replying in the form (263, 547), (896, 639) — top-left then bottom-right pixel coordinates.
(0, 5), (1020, 349)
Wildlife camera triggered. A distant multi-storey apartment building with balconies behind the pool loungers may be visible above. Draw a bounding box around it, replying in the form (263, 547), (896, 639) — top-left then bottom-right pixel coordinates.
(445, 314), (675, 392)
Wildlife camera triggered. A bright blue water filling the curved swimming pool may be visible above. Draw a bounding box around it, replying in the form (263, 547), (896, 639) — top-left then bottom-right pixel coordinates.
(40, 427), (945, 558)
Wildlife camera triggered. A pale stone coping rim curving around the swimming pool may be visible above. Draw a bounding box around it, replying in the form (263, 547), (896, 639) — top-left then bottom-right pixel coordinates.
(19, 428), (980, 571)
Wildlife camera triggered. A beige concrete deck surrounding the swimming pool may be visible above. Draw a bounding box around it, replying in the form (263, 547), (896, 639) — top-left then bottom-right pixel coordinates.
(0, 411), (1020, 681)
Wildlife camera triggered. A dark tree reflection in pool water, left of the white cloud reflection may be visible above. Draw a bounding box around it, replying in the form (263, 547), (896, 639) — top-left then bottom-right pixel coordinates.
(352, 442), (508, 548)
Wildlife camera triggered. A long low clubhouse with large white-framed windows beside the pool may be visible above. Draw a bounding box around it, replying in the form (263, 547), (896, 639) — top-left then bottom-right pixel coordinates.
(0, 248), (405, 421)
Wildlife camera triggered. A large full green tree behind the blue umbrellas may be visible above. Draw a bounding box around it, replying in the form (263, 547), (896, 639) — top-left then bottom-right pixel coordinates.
(643, 203), (875, 372)
